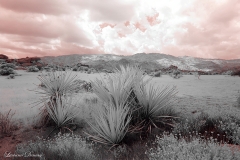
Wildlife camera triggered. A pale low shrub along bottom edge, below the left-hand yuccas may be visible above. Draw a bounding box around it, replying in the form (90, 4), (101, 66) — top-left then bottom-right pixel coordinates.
(16, 134), (96, 160)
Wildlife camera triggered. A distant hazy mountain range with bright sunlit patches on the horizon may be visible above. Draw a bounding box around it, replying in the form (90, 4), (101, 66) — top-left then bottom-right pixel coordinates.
(41, 53), (240, 72)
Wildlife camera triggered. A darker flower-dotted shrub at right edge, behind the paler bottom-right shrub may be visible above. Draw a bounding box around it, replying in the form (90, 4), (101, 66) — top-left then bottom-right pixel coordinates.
(172, 113), (240, 144)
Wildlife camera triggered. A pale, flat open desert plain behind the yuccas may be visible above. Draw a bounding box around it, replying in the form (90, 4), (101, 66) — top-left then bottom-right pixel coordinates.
(0, 70), (240, 120)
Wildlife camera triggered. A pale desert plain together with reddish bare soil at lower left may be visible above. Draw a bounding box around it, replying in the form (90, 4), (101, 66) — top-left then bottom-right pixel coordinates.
(0, 70), (240, 157)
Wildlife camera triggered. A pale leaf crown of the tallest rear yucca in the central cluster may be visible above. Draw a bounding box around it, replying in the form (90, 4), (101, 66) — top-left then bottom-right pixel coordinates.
(92, 66), (148, 108)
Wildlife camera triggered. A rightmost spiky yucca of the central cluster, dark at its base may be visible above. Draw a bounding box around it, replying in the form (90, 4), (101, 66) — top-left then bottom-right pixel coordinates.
(135, 83), (177, 129)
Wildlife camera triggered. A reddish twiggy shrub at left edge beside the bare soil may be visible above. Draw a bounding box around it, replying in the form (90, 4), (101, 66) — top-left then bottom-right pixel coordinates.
(0, 109), (17, 136)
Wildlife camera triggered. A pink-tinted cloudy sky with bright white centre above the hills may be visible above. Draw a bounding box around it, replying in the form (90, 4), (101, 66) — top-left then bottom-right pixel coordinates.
(0, 0), (240, 59)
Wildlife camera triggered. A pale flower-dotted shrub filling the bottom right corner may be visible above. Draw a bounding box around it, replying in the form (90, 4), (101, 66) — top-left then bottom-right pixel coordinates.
(146, 134), (240, 160)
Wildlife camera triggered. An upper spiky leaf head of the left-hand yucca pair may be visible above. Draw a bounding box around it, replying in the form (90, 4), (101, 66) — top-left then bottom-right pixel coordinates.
(36, 72), (78, 103)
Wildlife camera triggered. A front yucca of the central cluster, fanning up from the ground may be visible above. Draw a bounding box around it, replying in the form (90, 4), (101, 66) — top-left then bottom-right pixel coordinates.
(87, 102), (131, 146)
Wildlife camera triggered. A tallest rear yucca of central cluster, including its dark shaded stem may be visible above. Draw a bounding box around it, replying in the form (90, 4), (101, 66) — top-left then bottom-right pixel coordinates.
(92, 66), (151, 136)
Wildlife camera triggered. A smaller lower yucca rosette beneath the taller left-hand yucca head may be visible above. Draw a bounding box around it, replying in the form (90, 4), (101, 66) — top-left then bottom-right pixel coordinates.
(45, 95), (79, 128)
